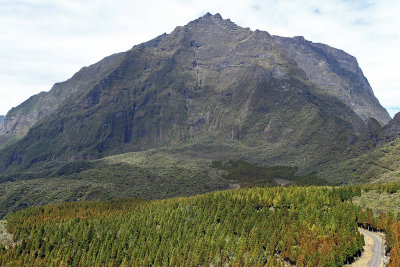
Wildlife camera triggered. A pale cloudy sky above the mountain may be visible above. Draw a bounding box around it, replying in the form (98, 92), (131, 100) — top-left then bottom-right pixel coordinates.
(0, 0), (400, 116)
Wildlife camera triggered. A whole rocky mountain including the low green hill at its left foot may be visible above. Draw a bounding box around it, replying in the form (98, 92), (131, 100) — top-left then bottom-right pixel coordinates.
(0, 13), (390, 217)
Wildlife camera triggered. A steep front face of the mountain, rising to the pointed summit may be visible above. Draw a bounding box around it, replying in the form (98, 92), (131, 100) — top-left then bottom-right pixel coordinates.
(0, 14), (365, 178)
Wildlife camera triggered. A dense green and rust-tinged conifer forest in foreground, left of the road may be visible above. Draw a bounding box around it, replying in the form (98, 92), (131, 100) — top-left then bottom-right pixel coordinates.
(0, 187), (364, 266)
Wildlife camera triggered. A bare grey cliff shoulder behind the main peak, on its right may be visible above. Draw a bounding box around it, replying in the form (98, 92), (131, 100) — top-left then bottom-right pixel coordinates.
(274, 36), (390, 126)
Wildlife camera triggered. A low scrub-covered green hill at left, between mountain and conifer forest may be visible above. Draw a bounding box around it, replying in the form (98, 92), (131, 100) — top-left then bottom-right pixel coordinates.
(0, 151), (229, 218)
